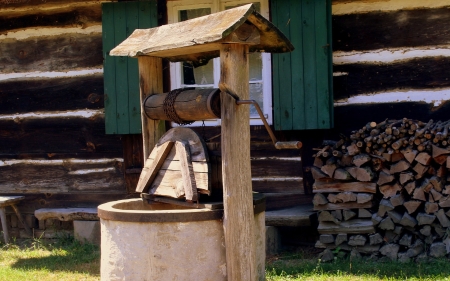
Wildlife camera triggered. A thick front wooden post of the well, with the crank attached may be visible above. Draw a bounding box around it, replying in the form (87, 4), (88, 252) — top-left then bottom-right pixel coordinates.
(220, 44), (257, 281)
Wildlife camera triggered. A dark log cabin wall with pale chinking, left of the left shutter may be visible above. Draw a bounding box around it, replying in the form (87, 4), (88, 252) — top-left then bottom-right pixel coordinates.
(0, 0), (127, 226)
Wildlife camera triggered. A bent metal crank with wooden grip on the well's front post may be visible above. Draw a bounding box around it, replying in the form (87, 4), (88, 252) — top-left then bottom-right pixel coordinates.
(219, 83), (302, 149)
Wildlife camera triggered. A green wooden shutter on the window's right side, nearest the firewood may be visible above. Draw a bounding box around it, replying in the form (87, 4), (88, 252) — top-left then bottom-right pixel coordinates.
(271, 0), (333, 130)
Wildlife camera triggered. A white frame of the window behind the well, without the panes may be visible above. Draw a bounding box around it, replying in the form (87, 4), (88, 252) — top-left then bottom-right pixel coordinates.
(167, 0), (273, 126)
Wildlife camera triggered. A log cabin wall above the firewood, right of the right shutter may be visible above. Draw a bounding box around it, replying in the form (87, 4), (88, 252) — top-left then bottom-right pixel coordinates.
(332, 0), (450, 133)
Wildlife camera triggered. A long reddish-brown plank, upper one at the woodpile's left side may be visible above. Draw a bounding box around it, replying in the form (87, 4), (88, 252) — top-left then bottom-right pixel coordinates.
(313, 180), (377, 193)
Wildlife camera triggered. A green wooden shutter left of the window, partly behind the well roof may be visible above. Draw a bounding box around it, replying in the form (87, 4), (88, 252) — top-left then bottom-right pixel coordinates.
(102, 1), (158, 134)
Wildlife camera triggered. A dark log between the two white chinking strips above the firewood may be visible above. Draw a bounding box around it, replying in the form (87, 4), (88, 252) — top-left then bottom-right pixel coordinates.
(333, 57), (450, 99)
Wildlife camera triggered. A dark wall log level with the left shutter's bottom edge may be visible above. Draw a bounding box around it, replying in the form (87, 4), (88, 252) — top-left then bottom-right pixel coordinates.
(0, 117), (122, 155)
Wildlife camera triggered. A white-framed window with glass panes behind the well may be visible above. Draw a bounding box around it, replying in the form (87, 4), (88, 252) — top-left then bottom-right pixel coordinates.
(167, 0), (272, 126)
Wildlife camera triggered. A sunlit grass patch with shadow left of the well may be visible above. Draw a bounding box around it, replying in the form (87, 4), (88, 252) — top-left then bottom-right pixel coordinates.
(0, 232), (100, 281)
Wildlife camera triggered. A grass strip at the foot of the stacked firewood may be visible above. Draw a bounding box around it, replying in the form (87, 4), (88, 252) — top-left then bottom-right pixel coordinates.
(266, 246), (450, 281)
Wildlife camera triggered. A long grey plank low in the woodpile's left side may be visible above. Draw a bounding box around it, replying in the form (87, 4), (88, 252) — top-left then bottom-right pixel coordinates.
(317, 219), (375, 234)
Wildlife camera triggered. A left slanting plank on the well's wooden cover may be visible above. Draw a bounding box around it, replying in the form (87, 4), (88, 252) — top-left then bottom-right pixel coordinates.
(136, 141), (174, 193)
